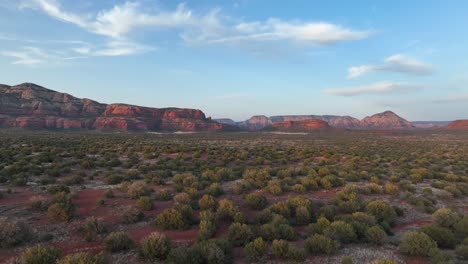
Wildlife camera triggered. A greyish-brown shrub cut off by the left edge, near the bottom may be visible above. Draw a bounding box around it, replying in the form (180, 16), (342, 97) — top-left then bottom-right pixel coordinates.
(0, 218), (33, 248)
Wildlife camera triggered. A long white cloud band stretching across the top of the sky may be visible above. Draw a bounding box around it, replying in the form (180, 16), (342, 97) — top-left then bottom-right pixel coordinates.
(28, 0), (371, 44)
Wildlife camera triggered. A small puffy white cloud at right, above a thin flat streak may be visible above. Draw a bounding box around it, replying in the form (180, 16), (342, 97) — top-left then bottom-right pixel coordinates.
(348, 54), (434, 79)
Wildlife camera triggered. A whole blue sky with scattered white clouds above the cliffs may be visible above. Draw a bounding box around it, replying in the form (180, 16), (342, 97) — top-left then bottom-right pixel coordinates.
(0, 0), (468, 121)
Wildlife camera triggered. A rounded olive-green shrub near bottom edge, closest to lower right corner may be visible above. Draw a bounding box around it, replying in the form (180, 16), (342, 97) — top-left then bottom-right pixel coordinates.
(399, 232), (437, 257)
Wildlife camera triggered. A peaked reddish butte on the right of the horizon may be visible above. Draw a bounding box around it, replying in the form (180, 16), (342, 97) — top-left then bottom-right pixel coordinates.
(361, 111), (414, 129)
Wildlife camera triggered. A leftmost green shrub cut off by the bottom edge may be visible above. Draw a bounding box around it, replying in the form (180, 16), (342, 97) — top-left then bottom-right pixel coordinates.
(20, 245), (62, 264)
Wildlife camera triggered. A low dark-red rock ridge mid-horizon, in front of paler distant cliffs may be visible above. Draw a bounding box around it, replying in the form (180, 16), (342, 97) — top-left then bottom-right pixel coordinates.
(265, 119), (331, 132)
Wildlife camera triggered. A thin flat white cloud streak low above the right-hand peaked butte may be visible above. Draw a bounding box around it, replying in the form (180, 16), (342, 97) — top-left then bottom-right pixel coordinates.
(324, 81), (423, 97)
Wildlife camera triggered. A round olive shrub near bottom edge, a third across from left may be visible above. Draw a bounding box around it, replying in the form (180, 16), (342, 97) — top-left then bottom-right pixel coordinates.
(140, 232), (172, 261)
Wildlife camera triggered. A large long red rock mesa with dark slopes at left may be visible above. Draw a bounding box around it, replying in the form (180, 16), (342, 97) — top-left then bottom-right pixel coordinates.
(0, 83), (232, 131)
